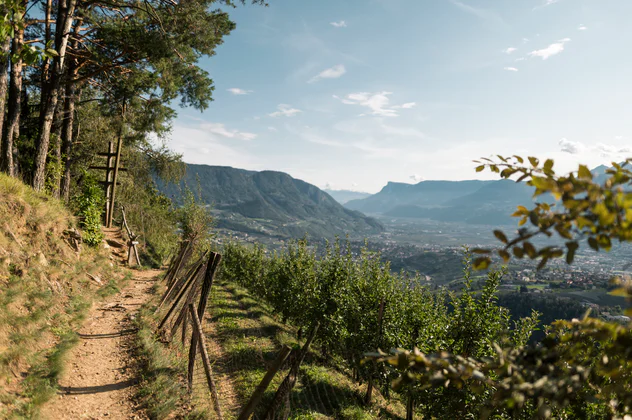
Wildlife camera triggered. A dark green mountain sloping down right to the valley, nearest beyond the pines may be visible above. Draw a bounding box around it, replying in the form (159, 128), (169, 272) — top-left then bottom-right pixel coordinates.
(159, 164), (383, 237)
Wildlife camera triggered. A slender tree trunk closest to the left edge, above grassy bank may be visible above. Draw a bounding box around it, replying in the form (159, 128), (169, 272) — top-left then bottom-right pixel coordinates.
(0, 18), (26, 176)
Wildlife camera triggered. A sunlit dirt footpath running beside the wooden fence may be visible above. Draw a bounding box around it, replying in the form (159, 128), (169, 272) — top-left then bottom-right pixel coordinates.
(41, 270), (160, 419)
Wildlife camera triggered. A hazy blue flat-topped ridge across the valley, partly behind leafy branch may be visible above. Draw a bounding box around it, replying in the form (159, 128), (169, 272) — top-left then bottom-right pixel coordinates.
(345, 165), (608, 225)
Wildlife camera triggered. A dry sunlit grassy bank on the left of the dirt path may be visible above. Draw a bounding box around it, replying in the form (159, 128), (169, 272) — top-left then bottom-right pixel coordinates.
(0, 175), (126, 418)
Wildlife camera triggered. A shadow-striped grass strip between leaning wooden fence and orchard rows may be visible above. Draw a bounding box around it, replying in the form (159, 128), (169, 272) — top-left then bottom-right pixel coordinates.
(207, 281), (405, 419)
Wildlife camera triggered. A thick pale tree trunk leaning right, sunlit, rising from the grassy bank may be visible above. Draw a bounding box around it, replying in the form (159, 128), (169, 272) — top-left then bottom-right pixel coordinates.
(33, 0), (77, 191)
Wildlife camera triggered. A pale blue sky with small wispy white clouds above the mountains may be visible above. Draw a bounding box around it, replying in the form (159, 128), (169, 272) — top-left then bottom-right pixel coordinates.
(169, 0), (632, 192)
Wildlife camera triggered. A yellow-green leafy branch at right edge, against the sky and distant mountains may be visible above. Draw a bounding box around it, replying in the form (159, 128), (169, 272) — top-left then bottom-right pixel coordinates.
(474, 156), (632, 269)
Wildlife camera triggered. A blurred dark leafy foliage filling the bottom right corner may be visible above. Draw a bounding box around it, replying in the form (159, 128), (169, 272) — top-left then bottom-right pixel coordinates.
(368, 317), (632, 419)
